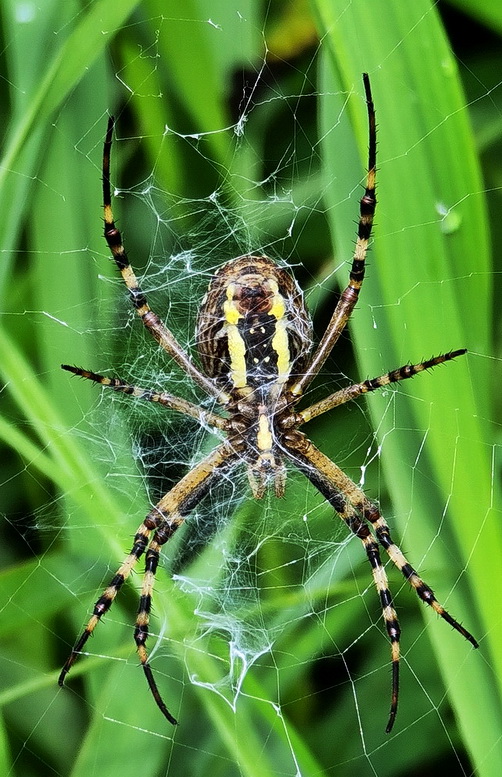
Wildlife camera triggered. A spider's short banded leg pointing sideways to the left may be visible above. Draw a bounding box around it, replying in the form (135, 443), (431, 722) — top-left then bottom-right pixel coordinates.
(61, 364), (228, 429)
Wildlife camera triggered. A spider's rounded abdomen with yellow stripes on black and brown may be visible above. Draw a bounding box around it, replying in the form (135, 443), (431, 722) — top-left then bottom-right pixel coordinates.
(197, 256), (312, 396)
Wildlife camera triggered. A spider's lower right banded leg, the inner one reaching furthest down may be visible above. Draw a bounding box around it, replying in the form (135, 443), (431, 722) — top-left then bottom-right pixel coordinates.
(292, 442), (401, 733)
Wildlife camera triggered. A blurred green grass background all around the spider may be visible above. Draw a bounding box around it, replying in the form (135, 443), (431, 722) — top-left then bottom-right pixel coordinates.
(0, 0), (502, 777)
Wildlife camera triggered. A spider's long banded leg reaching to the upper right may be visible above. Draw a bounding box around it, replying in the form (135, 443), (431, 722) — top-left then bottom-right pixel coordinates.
(291, 73), (376, 396)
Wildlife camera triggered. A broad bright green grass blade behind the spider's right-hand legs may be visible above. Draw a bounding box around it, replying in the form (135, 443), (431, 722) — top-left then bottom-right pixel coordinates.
(315, 0), (502, 774)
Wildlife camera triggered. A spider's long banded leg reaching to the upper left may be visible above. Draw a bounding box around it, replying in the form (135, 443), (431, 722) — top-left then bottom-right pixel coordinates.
(103, 116), (230, 405)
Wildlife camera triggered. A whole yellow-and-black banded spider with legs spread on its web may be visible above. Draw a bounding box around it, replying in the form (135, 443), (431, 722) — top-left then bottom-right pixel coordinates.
(59, 73), (478, 733)
